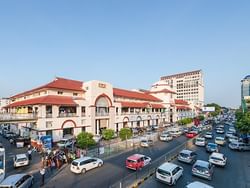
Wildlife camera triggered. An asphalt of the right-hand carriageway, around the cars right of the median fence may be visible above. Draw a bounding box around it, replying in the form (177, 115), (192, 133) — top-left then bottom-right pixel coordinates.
(140, 126), (250, 188)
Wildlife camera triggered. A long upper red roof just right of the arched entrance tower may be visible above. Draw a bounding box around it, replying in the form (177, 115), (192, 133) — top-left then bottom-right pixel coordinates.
(113, 88), (161, 102)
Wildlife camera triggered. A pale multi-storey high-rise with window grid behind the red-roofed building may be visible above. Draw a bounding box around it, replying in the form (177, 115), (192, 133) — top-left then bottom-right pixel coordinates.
(161, 70), (204, 108)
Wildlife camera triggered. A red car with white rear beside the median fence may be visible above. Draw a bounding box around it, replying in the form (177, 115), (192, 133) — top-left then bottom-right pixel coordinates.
(126, 154), (151, 170)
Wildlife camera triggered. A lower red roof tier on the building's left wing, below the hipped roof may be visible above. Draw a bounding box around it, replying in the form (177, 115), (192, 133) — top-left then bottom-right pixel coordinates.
(5, 95), (76, 108)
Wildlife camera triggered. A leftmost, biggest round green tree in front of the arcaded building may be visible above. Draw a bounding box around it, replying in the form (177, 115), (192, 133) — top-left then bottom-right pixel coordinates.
(76, 132), (96, 149)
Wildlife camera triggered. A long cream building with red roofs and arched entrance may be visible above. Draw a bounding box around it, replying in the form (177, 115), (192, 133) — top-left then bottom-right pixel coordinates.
(0, 78), (202, 142)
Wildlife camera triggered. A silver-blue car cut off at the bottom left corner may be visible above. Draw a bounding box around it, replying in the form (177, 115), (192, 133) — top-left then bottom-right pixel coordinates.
(0, 174), (34, 188)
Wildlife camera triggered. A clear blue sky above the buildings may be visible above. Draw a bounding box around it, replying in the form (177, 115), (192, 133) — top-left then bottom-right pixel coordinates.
(0, 0), (250, 107)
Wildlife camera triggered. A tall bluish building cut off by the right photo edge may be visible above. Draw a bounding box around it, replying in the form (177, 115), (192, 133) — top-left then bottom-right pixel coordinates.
(241, 75), (250, 110)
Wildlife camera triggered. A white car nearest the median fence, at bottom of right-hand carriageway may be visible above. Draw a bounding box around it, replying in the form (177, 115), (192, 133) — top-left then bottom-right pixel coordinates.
(155, 162), (183, 185)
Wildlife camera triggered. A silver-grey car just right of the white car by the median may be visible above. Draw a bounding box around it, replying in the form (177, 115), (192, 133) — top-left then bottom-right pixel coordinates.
(192, 160), (213, 180)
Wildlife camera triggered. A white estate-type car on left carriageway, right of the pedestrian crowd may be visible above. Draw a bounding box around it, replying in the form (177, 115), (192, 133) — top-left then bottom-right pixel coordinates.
(70, 157), (103, 174)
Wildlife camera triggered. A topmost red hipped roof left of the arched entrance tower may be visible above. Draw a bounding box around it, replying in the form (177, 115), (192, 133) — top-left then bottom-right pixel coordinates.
(11, 77), (84, 98)
